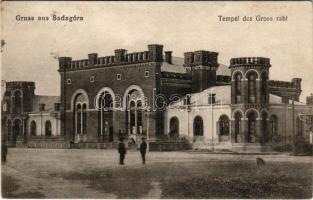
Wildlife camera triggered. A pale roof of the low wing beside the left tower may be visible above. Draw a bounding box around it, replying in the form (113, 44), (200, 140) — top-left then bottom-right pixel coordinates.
(32, 95), (60, 112)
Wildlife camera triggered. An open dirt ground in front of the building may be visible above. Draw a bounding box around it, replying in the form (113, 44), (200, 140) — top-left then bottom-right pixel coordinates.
(1, 148), (312, 199)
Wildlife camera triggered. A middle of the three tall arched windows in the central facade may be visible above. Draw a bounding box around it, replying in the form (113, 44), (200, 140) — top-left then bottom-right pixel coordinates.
(98, 91), (113, 142)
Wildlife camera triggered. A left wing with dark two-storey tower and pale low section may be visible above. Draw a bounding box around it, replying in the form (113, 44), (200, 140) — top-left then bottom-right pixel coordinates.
(1, 81), (61, 146)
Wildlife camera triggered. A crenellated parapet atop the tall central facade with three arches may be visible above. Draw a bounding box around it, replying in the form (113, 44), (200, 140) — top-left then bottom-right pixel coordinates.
(59, 44), (163, 71)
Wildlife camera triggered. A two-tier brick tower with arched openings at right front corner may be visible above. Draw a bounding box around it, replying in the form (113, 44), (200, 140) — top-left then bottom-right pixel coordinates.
(229, 57), (271, 146)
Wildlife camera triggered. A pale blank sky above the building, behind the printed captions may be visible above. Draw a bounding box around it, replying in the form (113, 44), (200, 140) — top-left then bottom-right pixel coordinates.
(1, 1), (313, 101)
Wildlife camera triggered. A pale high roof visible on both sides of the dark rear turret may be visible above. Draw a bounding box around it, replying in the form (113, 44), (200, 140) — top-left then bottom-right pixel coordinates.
(161, 56), (230, 76)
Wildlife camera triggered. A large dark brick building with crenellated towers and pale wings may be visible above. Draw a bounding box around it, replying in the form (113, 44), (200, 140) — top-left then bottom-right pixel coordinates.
(2, 44), (313, 150)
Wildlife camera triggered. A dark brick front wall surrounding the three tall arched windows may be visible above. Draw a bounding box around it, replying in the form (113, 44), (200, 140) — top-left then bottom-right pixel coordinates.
(62, 62), (163, 141)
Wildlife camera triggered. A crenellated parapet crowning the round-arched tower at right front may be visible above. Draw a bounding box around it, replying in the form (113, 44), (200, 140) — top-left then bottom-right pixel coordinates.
(230, 57), (271, 67)
